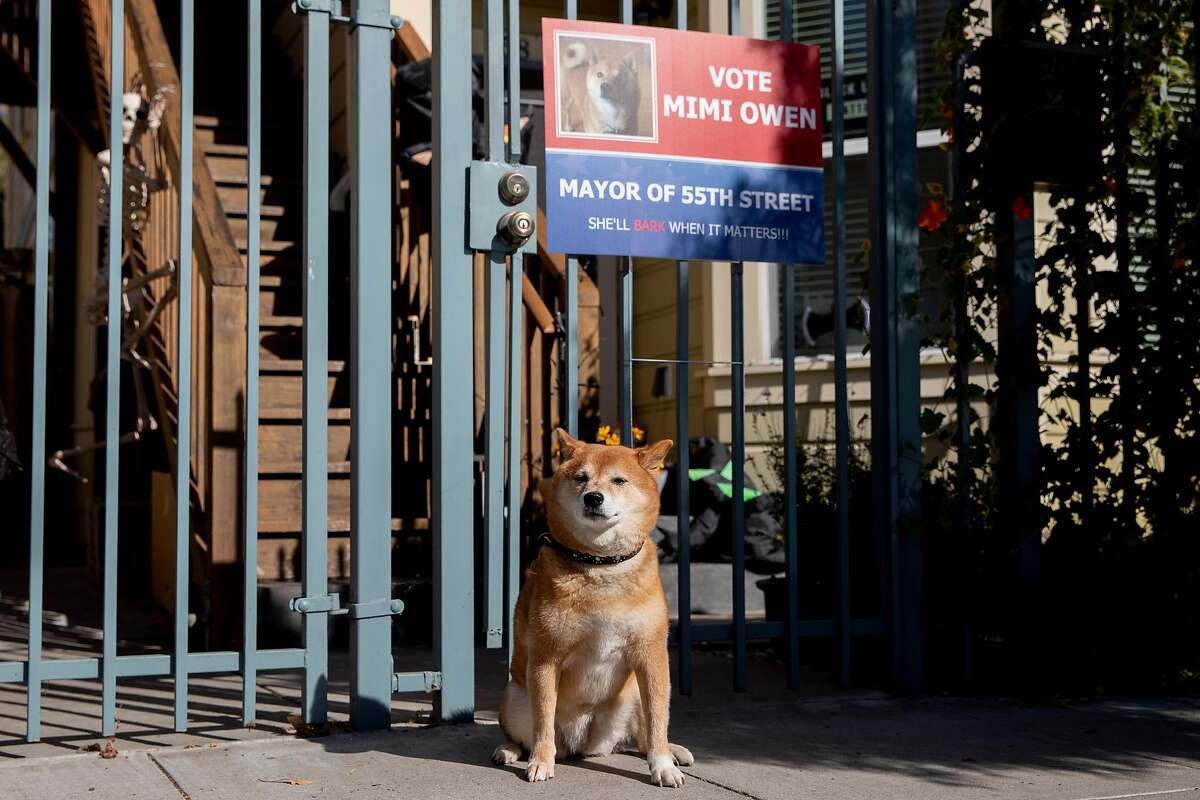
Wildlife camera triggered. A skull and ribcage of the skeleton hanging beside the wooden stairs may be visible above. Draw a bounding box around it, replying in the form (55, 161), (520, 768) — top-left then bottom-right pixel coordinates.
(96, 76), (174, 236)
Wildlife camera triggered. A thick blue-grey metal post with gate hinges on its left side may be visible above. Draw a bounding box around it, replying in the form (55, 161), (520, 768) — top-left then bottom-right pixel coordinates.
(350, 0), (394, 730)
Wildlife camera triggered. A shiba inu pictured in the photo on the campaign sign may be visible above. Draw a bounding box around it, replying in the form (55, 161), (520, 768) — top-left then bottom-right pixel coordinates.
(560, 42), (642, 136)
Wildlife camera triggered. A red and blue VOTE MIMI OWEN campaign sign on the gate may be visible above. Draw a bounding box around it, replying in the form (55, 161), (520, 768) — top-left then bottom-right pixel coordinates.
(542, 19), (824, 264)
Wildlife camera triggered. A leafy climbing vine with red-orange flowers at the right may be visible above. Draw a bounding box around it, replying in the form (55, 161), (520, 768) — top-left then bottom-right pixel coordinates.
(918, 0), (1200, 691)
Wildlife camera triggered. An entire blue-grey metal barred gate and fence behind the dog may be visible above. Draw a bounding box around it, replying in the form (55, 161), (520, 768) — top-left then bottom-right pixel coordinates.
(0, 0), (920, 741)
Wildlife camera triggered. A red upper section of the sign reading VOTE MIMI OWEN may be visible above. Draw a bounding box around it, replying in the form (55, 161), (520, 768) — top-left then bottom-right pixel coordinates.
(541, 19), (823, 167)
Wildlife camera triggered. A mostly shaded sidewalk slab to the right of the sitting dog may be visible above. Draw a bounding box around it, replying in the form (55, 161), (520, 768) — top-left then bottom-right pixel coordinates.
(671, 700), (1200, 800)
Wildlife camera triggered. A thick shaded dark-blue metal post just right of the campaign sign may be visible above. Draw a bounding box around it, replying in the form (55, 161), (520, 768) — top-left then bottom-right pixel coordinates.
(870, 0), (924, 694)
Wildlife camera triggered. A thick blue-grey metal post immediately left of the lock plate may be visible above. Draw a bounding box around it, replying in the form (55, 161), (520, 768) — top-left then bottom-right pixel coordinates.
(432, 0), (475, 722)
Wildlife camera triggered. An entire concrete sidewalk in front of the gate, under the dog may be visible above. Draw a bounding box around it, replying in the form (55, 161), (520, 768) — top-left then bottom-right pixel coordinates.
(0, 697), (1200, 800)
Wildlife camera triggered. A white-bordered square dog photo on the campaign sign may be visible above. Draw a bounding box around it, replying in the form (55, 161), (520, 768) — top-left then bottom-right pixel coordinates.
(554, 34), (658, 142)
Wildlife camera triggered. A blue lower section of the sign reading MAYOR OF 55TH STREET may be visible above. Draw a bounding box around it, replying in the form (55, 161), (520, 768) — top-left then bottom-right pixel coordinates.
(546, 151), (826, 265)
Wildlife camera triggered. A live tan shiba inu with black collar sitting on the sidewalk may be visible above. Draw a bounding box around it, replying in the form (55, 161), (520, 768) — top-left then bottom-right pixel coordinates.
(492, 429), (692, 788)
